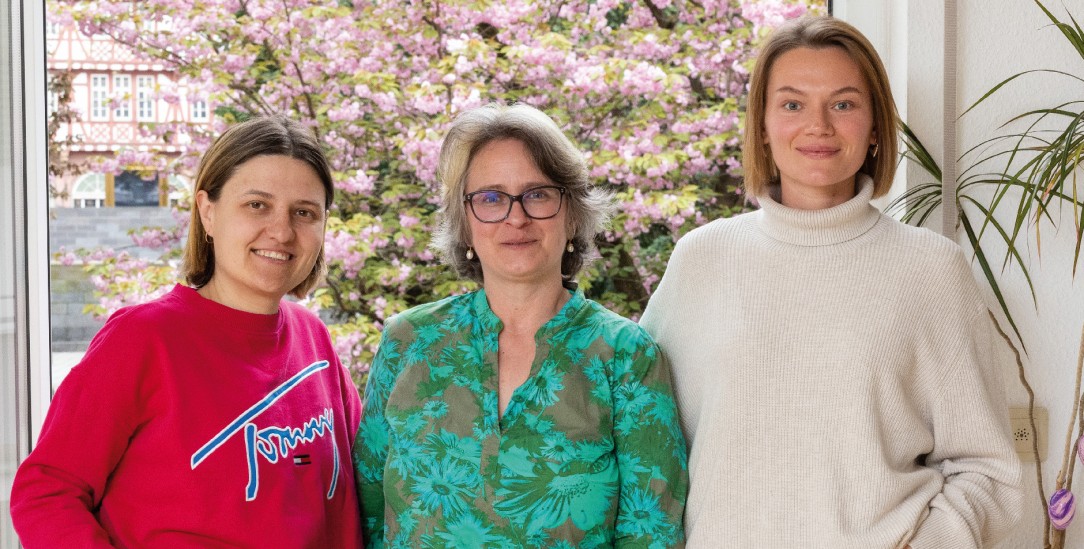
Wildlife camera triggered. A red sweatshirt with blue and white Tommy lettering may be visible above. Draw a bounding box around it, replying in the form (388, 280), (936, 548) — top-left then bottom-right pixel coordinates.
(11, 285), (361, 549)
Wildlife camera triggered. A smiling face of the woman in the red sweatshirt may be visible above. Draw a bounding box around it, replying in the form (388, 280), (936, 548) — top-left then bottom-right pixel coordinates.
(196, 155), (325, 314)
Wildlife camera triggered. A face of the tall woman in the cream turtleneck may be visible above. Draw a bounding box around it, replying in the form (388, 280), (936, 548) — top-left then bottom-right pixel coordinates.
(764, 48), (877, 209)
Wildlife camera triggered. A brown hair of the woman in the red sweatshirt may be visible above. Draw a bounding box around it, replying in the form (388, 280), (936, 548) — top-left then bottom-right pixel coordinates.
(182, 115), (335, 297)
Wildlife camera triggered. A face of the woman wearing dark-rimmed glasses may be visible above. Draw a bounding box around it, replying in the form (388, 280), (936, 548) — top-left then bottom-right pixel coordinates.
(464, 139), (569, 286)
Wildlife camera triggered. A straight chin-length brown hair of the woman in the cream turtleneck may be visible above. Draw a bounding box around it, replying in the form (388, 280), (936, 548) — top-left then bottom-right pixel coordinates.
(741, 15), (899, 196)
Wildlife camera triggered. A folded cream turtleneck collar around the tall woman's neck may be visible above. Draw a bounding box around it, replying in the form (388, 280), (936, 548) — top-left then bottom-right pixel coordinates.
(757, 174), (880, 246)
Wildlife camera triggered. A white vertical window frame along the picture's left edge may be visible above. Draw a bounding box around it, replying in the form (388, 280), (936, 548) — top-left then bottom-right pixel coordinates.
(0, 2), (52, 547)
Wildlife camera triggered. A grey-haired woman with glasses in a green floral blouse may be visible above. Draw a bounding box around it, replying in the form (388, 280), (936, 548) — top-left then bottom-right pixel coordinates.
(354, 105), (688, 549)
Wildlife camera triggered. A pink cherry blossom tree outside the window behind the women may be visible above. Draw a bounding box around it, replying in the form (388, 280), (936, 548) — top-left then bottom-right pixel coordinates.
(48, 0), (823, 382)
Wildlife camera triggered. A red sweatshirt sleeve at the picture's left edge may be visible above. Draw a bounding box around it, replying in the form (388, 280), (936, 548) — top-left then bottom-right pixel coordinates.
(11, 318), (146, 549)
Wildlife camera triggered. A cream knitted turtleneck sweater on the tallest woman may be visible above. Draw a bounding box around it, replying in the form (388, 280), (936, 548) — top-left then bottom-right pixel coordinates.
(641, 176), (1022, 549)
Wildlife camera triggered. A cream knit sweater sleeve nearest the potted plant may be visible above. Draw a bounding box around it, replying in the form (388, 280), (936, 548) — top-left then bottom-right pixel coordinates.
(911, 272), (1023, 549)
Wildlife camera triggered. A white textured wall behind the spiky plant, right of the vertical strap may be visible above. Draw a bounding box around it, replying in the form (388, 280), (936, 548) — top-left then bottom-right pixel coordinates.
(956, 0), (1084, 548)
